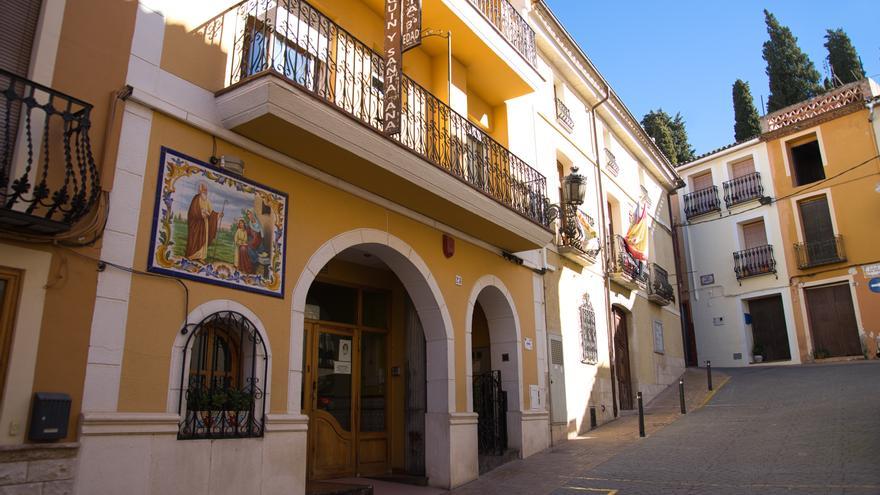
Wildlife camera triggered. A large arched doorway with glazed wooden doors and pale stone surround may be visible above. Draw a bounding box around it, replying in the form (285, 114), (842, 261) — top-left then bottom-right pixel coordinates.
(291, 229), (454, 486)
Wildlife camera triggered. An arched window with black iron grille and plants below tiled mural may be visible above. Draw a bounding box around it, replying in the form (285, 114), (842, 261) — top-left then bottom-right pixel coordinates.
(177, 311), (268, 439)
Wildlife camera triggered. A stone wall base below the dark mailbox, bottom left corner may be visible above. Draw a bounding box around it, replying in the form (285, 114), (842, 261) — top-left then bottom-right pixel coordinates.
(0, 443), (79, 495)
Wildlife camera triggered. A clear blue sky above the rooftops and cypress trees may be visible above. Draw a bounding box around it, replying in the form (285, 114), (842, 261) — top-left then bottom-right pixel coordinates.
(546, 0), (880, 153)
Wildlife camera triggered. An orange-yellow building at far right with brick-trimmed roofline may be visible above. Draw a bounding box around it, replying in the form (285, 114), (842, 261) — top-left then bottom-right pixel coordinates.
(761, 79), (880, 361)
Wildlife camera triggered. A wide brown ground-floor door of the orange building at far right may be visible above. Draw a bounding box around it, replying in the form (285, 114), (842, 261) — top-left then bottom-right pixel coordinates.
(804, 283), (862, 357)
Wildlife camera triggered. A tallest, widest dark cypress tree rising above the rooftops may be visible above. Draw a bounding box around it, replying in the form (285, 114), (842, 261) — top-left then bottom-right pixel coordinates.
(764, 10), (823, 112)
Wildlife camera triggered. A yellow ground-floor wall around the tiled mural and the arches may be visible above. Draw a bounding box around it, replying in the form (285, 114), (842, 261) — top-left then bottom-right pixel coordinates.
(119, 115), (538, 418)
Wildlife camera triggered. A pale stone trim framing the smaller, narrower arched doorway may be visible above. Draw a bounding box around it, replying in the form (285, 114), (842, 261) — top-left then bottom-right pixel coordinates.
(465, 275), (523, 448)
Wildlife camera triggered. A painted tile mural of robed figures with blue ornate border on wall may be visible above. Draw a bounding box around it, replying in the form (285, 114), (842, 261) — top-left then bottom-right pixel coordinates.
(147, 147), (287, 297)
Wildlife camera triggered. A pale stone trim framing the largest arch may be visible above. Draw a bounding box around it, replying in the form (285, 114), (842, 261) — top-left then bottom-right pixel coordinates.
(287, 229), (455, 404)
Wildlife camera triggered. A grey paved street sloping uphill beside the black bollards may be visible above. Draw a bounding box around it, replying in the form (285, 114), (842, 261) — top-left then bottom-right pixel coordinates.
(452, 361), (880, 495)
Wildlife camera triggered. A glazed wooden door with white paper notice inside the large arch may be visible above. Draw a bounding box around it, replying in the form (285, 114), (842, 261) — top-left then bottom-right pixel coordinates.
(307, 325), (358, 479)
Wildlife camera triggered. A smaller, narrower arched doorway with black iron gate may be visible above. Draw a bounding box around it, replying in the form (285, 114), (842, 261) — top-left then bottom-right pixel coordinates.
(468, 276), (522, 473)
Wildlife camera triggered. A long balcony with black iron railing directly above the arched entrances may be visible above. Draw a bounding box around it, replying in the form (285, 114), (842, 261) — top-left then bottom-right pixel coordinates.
(210, 0), (552, 252)
